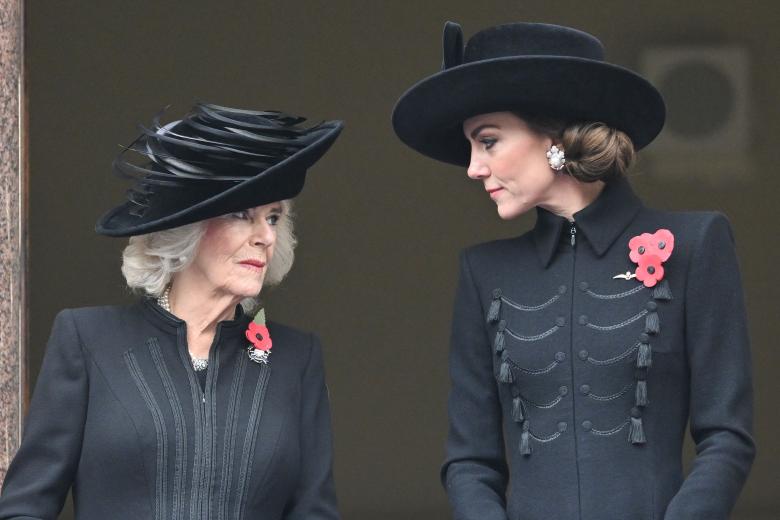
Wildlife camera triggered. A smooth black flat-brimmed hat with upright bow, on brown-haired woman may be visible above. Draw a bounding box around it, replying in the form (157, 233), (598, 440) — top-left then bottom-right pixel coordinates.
(393, 22), (666, 165)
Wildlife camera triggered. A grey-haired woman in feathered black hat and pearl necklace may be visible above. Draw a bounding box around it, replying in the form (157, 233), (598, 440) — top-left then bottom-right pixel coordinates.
(0, 104), (342, 520)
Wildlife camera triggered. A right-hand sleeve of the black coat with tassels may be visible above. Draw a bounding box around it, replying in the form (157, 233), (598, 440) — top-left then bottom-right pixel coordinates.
(665, 214), (755, 520)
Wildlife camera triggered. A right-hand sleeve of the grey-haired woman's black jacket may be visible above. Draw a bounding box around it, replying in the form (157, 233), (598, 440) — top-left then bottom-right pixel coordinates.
(284, 336), (340, 520)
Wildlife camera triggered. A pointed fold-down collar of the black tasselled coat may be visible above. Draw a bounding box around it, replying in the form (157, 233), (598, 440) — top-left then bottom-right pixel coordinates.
(532, 178), (642, 268)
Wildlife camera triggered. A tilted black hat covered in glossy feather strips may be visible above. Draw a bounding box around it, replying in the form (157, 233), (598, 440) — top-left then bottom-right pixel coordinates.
(95, 103), (343, 237)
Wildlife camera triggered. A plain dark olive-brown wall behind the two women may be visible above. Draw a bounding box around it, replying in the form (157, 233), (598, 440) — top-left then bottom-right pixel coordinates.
(26, 0), (780, 520)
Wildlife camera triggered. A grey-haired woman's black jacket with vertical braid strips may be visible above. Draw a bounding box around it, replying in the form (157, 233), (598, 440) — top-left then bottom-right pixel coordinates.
(0, 300), (339, 520)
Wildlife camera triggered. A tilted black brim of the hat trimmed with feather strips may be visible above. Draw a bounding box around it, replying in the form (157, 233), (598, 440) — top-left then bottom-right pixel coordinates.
(95, 121), (344, 237)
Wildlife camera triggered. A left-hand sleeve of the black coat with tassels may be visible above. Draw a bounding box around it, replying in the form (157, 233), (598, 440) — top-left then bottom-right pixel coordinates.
(441, 252), (508, 520)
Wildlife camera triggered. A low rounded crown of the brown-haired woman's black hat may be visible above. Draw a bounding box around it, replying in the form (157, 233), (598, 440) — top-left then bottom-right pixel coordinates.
(463, 23), (604, 63)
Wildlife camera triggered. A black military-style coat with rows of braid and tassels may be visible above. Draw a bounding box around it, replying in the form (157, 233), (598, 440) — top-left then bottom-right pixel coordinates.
(442, 180), (755, 520)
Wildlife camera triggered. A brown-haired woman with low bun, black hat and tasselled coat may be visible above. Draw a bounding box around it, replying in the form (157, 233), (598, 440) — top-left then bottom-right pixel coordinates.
(393, 23), (754, 520)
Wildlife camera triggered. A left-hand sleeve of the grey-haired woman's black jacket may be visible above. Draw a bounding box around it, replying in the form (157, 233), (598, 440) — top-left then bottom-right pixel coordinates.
(0, 310), (88, 520)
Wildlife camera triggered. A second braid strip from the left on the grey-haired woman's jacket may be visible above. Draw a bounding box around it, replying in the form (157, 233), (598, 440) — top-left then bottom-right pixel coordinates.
(147, 338), (187, 520)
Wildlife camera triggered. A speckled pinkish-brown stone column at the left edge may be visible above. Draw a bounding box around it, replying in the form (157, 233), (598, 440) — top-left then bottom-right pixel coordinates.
(0, 0), (27, 481)
